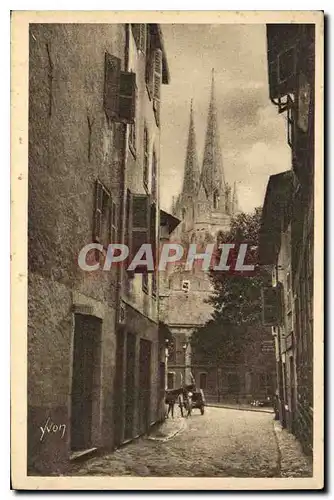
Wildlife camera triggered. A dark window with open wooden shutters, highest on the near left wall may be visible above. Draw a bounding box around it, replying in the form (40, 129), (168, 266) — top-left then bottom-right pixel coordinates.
(104, 52), (136, 123)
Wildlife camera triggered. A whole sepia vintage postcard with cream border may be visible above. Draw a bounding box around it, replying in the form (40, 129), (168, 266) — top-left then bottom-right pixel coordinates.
(11, 11), (324, 490)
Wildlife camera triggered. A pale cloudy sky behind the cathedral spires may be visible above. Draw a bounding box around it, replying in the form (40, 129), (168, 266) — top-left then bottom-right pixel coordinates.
(160, 24), (291, 212)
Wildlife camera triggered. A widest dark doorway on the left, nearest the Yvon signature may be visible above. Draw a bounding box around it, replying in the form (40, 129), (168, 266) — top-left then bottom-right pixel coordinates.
(71, 314), (102, 451)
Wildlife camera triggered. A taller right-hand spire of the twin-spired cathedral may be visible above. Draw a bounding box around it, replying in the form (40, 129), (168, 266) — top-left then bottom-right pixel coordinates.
(202, 69), (225, 197)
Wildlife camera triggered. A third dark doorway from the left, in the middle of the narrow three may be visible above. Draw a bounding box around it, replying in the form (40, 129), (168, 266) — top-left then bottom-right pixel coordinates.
(124, 333), (136, 439)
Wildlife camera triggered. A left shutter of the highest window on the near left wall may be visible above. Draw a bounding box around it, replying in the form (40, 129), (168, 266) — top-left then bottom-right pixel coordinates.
(104, 52), (121, 120)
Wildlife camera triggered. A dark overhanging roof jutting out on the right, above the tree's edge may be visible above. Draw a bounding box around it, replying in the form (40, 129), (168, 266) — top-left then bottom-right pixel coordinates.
(259, 170), (293, 265)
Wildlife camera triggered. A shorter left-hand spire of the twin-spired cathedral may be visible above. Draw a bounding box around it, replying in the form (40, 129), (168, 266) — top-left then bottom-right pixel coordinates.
(182, 100), (200, 196)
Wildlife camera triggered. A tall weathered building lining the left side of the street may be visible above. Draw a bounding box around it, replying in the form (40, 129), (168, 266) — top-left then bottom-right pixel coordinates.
(28, 24), (169, 475)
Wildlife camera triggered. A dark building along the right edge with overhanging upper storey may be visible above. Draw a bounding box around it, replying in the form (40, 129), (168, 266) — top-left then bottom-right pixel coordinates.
(261, 24), (315, 452)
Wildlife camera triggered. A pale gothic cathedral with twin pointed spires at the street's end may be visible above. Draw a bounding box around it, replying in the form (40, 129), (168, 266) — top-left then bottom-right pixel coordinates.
(161, 71), (238, 387)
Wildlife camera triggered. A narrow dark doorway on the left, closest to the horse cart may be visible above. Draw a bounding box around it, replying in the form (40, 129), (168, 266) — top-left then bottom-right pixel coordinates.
(139, 339), (151, 434)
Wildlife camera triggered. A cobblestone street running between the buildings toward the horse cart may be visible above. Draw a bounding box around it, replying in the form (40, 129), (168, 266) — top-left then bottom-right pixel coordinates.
(70, 407), (312, 477)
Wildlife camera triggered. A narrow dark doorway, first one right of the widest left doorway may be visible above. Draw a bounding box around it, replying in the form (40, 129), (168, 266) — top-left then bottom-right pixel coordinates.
(114, 330), (125, 446)
